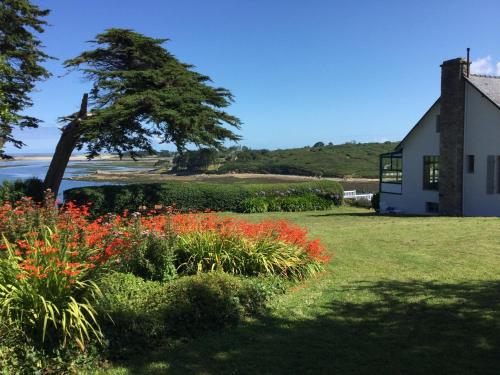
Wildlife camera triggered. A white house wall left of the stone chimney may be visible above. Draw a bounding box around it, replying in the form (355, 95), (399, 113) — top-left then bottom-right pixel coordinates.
(380, 102), (440, 215)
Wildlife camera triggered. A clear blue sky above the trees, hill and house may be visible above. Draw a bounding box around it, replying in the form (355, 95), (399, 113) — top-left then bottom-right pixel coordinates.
(5, 0), (500, 153)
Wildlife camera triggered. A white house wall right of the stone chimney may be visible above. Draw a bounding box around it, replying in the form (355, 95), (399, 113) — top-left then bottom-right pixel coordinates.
(463, 83), (500, 216)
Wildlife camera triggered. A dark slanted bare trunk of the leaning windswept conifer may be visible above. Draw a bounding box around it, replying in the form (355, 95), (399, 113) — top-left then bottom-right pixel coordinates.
(43, 94), (88, 196)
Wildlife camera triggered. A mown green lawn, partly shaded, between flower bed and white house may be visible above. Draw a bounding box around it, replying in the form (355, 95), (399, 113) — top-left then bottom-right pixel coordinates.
(93, 208), (500, 374)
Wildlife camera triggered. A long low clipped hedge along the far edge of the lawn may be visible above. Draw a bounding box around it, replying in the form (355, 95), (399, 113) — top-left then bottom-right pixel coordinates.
(64, 181), (343, 215)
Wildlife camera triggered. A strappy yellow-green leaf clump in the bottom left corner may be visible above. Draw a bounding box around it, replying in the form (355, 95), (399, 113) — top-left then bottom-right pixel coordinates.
(0, 231), (102, 350)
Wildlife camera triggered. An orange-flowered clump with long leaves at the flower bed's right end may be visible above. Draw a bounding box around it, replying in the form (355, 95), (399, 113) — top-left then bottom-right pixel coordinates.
(172, 215), (328, 279)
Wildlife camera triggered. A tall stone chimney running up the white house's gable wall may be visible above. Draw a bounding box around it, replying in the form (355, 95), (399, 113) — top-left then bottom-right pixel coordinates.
(439, 58), (467, 216)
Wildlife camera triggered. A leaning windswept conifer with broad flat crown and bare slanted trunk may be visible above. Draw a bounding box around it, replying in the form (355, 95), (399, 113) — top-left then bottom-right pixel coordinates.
(45, 29), (240, 192)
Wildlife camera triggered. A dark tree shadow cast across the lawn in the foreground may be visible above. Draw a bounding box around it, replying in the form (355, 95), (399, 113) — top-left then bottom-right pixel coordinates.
(113, 281), (500, 374)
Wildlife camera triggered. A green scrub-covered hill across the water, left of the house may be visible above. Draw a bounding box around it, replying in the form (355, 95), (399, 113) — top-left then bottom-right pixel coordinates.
(217, 142), (397, 178)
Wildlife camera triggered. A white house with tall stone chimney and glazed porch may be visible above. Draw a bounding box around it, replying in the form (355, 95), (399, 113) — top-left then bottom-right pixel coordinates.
(380, 54), (500, 216)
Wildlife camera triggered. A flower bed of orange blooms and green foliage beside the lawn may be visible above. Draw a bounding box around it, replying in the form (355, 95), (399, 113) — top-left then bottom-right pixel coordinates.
(0, 198), (329, 374)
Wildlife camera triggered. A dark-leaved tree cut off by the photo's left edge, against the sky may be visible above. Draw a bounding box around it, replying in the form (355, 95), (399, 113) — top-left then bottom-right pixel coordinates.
(0, 0), (50, 158)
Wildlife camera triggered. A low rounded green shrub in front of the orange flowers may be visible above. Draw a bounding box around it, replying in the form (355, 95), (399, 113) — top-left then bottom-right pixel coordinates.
(98, 273), (287, 357)
